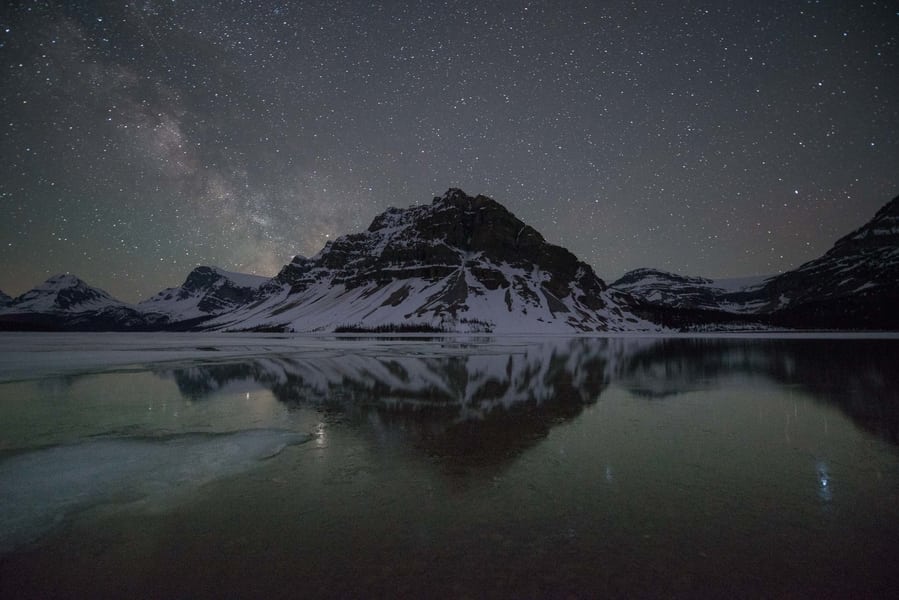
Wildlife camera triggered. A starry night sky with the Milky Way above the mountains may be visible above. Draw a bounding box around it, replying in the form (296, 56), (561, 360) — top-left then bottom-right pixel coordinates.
(0, 0), (899, 302)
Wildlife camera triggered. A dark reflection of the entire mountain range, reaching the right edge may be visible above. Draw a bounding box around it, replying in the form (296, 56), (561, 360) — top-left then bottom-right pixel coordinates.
(161, 338), (899, 460)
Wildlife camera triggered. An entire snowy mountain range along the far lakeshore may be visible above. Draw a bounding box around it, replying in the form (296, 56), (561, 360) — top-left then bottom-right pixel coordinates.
(0, 189), (899, 333)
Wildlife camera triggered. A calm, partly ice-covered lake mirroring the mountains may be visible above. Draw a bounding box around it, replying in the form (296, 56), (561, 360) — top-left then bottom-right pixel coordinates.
(0, 336), (899, 598)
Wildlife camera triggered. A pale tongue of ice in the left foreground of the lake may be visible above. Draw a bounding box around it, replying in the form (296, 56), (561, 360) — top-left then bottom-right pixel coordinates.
(0, 429), (311, 553)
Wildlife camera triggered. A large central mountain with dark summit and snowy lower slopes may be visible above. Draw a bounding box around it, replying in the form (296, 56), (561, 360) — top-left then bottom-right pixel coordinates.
(206, 189), (656, 333)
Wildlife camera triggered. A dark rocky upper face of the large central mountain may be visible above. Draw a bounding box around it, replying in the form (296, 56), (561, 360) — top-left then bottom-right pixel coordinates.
(275, 189), (606, 310)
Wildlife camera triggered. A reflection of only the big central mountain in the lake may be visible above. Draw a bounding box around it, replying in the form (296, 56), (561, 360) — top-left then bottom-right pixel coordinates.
(163, 339), (619, 464)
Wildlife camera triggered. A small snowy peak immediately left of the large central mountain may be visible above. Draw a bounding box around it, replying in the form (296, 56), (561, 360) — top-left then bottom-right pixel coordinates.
(137, 267), (270, 323)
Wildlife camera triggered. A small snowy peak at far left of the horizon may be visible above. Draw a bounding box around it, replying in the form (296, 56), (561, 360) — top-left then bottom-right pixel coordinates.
(0, 274), (153, 331)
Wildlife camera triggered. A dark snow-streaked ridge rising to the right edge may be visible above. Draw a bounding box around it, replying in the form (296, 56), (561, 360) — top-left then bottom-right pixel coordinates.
(611, 197), (899, 329)
